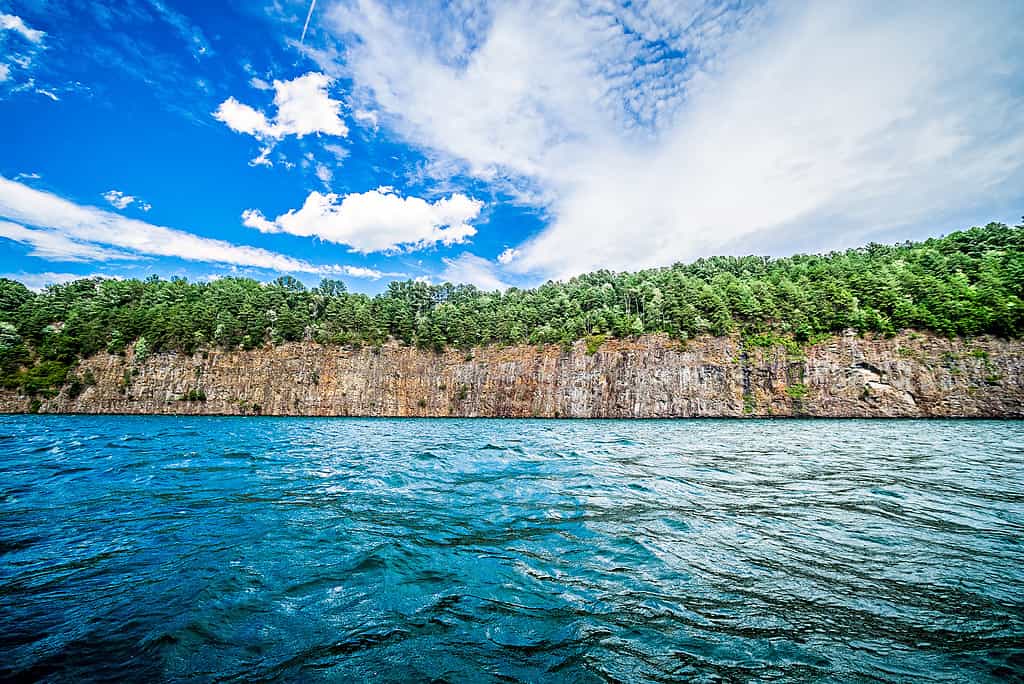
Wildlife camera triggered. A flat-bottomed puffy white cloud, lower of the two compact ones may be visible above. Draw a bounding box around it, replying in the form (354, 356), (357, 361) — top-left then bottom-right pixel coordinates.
(242, 187), (483, 254)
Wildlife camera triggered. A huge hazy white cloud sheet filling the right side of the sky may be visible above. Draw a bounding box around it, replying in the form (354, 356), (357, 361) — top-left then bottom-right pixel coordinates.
(319, 0), (1024, 276)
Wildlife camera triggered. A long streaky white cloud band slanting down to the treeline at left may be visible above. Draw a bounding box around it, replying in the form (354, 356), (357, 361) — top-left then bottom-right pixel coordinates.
(0, 177), (344, 273)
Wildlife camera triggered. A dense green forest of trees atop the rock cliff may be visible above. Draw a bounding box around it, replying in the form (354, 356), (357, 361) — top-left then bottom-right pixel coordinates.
(0, 221), (1024, 394)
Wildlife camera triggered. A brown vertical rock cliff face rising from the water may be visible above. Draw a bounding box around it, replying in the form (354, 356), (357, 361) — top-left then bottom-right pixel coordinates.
(0, 333), (1024, 418)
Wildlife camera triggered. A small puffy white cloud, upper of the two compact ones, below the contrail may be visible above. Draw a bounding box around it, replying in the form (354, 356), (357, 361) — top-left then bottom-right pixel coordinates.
(213, 73), (348, 140)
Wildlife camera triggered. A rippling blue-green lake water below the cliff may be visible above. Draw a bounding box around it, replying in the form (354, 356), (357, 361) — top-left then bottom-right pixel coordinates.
(0, 417), (1024, 682)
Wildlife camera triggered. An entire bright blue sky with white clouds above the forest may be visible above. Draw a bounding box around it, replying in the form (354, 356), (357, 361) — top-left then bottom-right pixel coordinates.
(0, 0), (1024, 293)
